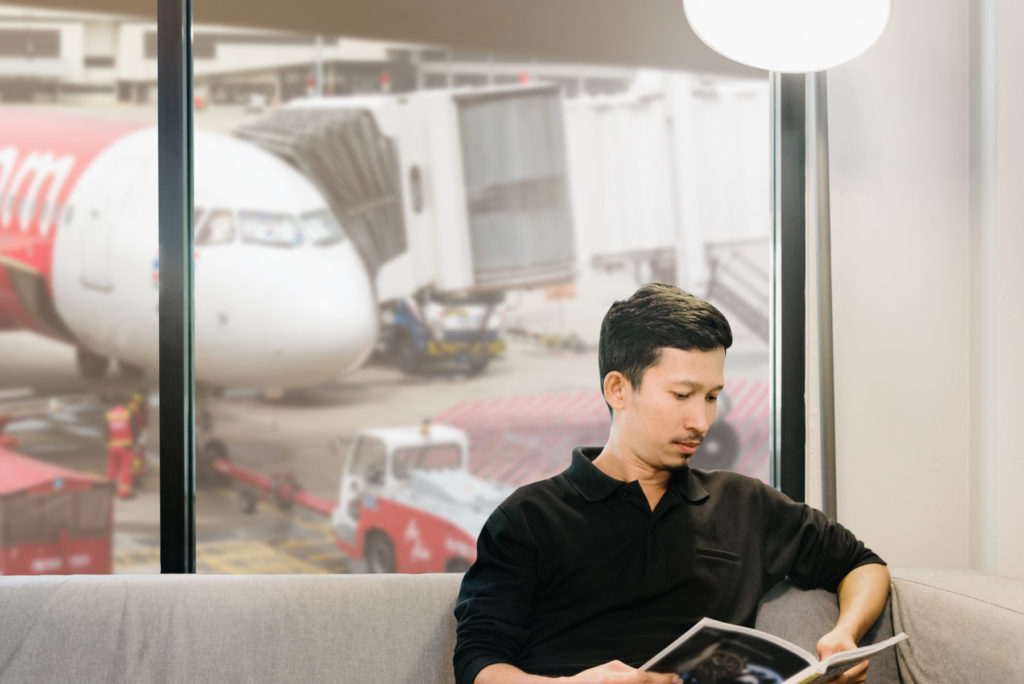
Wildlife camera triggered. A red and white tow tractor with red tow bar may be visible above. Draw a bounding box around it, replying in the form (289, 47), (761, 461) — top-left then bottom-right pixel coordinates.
(212, 421), (512, 573)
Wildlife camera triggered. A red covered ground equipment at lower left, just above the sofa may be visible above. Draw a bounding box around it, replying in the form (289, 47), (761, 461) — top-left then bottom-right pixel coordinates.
(0, 446), (114, 574)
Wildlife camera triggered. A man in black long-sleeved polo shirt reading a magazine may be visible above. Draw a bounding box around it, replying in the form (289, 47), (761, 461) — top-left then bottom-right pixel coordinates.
(455, 285), (889, 684)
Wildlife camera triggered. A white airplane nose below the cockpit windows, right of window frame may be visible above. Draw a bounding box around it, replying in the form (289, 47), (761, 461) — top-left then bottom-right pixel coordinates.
(196, 243), (378, 389)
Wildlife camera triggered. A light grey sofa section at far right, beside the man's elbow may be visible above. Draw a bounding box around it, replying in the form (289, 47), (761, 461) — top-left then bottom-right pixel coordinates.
(893, 568), (1024, 684)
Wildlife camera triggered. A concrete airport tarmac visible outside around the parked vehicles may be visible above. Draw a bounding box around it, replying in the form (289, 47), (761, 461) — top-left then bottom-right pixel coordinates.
(0, 274), (767, 572)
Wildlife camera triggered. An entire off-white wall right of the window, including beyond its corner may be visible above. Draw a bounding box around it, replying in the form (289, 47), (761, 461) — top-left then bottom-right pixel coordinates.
(828, 0), (1024, 576)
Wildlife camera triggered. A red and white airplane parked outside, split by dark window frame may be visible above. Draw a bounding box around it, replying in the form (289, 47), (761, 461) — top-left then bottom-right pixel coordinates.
(0, 109), (379, 391)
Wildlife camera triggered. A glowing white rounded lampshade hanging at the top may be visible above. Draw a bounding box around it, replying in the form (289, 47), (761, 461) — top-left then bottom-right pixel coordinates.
(683, 0), (891, 73)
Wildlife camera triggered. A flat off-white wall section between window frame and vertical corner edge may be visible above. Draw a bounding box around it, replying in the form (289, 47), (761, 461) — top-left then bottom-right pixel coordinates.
(823, 0), (971, 566)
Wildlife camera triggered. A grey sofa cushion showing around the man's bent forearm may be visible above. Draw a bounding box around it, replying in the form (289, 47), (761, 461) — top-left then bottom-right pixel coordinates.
(755, 580), (899, 684)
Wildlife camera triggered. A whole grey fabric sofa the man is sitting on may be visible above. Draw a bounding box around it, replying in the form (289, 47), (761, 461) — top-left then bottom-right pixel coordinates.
(0, 569), (1024, 684)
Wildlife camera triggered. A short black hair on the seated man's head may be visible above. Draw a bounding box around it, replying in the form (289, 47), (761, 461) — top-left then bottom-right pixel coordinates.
(597, 283), (732, 403)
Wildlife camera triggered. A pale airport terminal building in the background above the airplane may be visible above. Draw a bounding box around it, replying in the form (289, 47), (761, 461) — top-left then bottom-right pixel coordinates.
(0, 5), (635, 104)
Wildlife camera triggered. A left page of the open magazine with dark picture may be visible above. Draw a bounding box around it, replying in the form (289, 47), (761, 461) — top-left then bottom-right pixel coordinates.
(641, 617), (817, 684)
